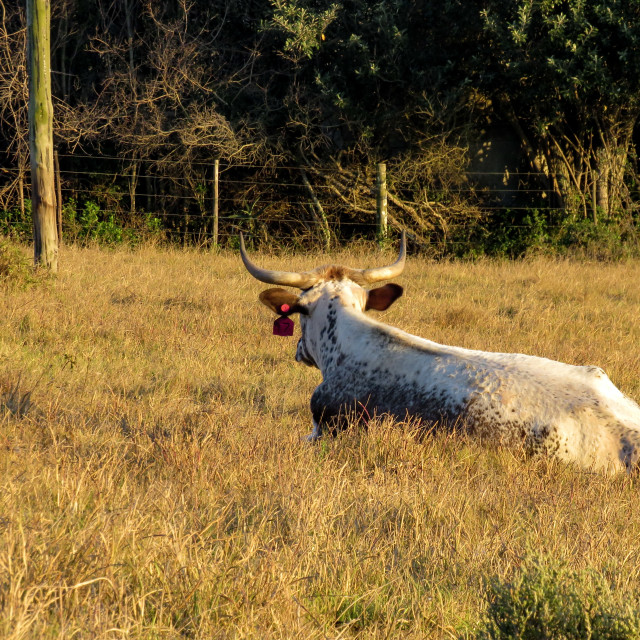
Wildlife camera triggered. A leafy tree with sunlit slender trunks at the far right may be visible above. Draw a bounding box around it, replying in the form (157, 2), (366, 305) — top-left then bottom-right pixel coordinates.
(475, 0), (640, 221)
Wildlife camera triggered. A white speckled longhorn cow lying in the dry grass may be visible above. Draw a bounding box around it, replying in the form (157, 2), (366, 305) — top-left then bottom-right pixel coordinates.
(240, 234), (640, 473)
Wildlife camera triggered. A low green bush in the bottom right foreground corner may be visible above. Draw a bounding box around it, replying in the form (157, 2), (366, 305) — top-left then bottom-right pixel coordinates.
(476, 557), (640, 640)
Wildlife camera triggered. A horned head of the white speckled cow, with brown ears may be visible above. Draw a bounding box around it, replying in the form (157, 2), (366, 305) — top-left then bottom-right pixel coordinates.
(240, 232), (407, 366)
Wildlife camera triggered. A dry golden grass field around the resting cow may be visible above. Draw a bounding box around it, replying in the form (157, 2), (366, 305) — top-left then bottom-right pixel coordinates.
(0, 242), (640, 640)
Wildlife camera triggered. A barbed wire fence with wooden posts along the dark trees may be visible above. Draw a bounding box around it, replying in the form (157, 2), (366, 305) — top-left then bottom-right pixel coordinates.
(0, 154), (576, 250)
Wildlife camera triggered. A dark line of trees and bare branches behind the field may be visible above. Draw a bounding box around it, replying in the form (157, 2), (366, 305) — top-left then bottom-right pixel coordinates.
(0, 0), (640, 253)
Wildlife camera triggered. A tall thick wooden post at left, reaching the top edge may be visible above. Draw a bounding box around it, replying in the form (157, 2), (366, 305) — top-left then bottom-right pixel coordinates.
(27, 0), (58, 272)
